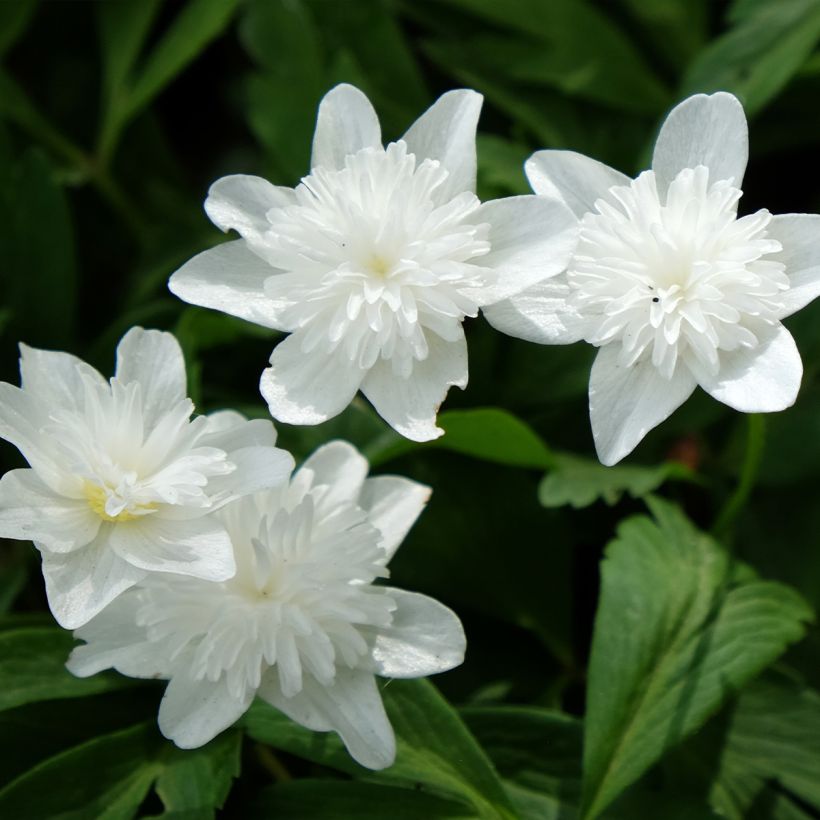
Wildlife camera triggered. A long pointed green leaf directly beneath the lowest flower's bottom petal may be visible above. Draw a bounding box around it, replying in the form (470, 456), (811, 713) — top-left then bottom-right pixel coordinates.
(242, 680), (514, 818)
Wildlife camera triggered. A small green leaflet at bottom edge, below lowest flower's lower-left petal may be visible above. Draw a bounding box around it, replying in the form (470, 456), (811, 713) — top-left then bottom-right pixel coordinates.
(156, 731), (242, 816)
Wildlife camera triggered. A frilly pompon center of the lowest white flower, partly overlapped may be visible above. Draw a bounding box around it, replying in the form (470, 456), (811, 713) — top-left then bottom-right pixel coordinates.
(138, 495), (396, 698)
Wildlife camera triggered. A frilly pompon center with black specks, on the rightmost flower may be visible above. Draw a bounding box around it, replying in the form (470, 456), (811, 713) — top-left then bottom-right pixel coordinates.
(568, 171), (789, 378)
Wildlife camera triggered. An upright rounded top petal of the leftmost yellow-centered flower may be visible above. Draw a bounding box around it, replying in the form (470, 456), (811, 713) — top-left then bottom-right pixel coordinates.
(117, 327), (188, 430)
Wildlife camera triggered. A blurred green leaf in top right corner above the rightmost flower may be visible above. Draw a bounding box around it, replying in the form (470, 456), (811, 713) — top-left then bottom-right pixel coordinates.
(681, 0), (820, 114)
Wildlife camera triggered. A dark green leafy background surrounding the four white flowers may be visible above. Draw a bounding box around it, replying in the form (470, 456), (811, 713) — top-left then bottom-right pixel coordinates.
(0, 0), (820, 820)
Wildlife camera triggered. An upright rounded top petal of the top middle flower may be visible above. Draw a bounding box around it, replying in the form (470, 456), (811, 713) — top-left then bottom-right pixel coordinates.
(310, 83), (382, 170)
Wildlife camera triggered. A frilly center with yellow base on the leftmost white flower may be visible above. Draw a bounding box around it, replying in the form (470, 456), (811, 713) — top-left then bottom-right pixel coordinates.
(46, 379), (236, 522)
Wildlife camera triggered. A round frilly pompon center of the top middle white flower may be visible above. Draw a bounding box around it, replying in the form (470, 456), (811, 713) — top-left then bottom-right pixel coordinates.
(262, 141), (491, 376)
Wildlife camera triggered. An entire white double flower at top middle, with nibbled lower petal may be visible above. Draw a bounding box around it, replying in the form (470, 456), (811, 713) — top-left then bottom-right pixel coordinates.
(169, 85), (577, 441)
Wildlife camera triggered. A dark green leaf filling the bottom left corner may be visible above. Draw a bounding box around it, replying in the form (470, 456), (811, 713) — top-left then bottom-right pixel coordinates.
(0, 724), (161, 820)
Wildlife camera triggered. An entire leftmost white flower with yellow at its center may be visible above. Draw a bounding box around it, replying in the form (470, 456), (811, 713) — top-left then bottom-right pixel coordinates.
(0, 328), (293, 629)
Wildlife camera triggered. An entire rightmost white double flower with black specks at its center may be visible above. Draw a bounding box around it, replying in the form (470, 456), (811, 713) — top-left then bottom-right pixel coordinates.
(487, 92), (820, 465)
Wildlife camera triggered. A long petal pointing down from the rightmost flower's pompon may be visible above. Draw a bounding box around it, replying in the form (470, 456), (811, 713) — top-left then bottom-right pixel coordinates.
(589, 344), (695, 466)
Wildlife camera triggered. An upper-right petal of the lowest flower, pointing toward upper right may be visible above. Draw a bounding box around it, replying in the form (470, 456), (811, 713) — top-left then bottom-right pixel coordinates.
(359, 475), (432, 561)
